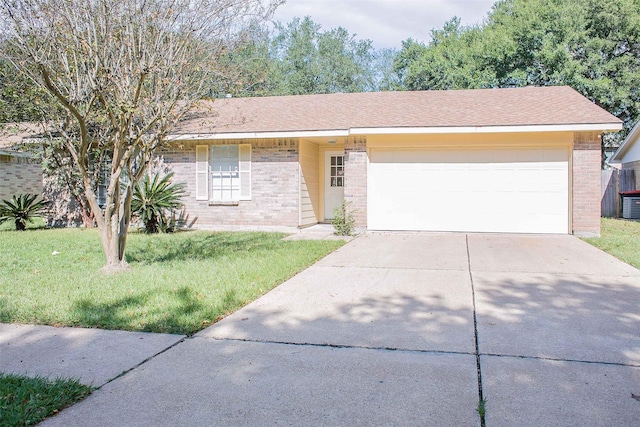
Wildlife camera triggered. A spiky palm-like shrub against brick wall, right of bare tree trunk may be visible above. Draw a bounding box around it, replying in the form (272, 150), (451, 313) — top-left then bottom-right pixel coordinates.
(131, 172), (185, 233)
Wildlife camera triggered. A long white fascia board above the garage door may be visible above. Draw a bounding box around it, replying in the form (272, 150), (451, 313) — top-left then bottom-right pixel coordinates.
(350, 123), (622, 135)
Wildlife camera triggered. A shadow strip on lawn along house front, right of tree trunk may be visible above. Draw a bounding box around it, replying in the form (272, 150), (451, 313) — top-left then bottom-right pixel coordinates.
(127, 232), (284, 264)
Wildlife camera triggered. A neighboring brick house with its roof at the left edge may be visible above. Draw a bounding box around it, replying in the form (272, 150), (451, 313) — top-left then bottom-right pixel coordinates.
(0, 123), (43, 200)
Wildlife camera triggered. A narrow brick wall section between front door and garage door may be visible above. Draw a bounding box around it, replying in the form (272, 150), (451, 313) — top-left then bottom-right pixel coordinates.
(344, 136), (367, 227)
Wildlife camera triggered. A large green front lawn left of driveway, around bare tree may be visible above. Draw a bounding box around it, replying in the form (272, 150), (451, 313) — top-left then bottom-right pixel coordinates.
(0, 229), (343, 334)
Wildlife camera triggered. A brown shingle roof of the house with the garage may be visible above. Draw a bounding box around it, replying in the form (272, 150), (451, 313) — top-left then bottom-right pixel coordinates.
(175, 86), (621, 134)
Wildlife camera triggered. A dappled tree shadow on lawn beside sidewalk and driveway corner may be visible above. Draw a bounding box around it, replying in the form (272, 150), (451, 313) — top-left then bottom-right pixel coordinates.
(71, 286), (238, 335)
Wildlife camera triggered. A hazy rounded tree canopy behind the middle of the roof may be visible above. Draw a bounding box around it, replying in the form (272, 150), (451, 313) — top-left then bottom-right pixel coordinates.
(215, 16), (388, 96)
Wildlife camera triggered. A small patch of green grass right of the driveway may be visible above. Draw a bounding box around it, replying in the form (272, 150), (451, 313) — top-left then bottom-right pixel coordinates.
(584, 218), (640, 268)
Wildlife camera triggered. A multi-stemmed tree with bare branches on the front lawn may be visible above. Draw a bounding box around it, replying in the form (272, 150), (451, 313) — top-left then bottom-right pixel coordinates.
(0, 0), (281, 270)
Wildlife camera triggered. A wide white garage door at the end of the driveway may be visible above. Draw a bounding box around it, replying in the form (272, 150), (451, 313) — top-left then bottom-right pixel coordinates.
(367, 147), (569, 234)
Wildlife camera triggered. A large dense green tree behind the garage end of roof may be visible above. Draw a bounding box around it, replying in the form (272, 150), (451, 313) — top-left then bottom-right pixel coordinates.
(396, 0), (640, 142)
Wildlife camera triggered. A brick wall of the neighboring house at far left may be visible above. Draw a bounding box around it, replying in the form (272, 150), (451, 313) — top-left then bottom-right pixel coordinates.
(0, 155), (42, 200)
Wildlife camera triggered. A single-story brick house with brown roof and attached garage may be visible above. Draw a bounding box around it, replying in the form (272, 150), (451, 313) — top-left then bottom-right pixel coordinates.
(161, 87), (622, 235)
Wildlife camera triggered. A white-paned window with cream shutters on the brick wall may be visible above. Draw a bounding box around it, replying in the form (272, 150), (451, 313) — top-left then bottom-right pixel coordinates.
(196, 144), (251, 203)
